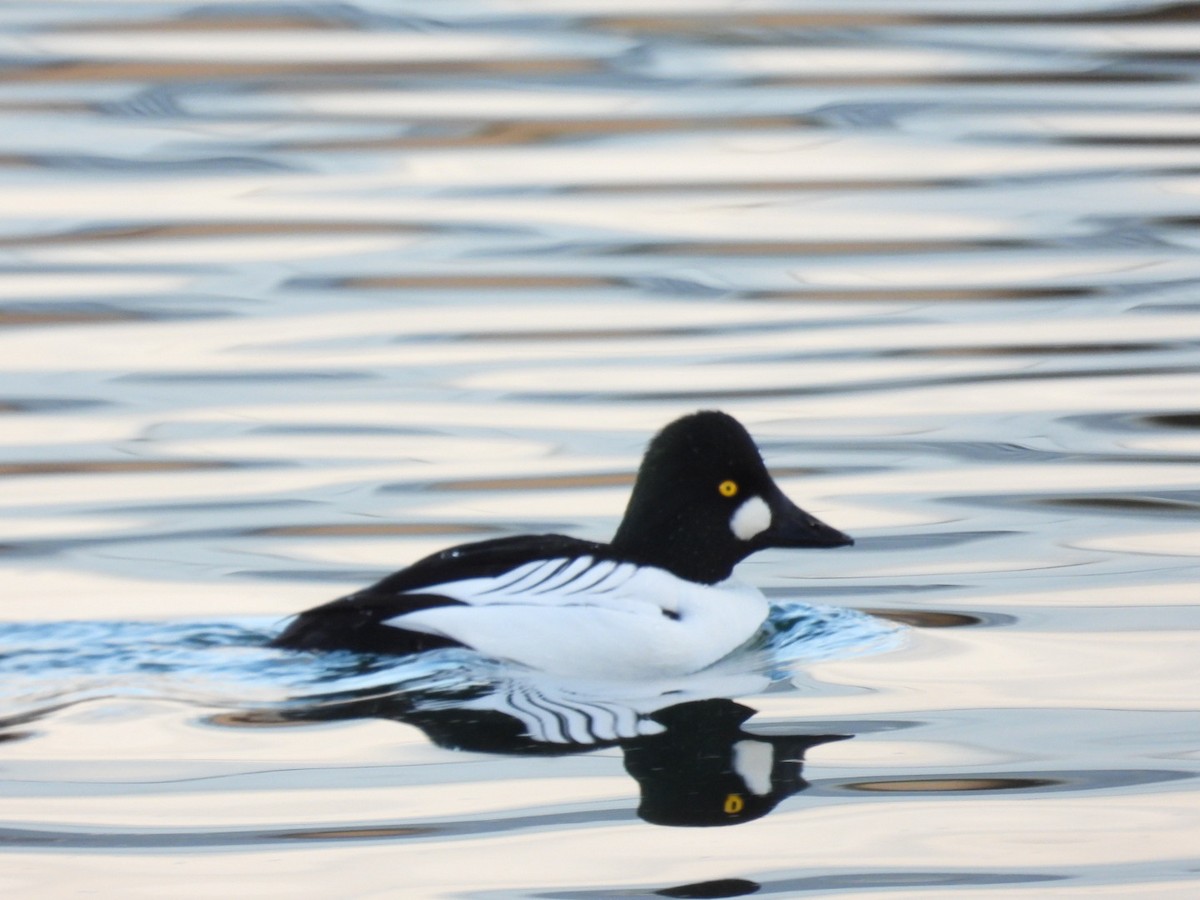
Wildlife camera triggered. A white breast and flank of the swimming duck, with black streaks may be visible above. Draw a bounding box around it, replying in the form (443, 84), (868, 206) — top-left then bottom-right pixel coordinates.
(385, 557), (767, 679)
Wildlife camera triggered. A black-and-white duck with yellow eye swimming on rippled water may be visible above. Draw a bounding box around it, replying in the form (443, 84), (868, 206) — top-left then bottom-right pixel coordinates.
(271, 410), (853, 680)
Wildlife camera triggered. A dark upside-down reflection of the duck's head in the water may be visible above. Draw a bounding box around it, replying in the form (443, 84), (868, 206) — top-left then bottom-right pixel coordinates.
(623, 700), (846, 826)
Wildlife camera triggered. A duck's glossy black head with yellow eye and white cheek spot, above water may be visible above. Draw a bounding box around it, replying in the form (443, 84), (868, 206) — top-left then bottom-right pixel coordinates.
(612, 412), (854, 584)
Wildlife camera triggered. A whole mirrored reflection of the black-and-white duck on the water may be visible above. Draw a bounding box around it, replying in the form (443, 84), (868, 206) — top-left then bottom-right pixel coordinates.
(262, 672), (851, 827)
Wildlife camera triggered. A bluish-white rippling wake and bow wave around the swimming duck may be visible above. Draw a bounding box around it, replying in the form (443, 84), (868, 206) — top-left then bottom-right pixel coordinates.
(0, 602), (902, 727)
